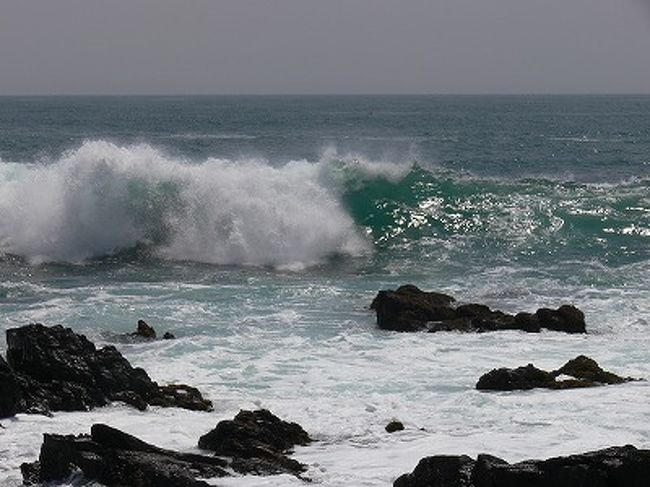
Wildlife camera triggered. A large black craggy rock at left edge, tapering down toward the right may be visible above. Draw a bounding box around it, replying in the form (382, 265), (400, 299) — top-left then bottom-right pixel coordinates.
(0, 324), (212, 414)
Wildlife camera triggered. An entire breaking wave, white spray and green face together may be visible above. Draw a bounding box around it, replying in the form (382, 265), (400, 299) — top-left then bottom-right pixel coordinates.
(0, 140), (650, 267)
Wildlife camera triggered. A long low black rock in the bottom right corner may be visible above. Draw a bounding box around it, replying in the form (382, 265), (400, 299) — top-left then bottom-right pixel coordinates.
(393, 445), (650, 487)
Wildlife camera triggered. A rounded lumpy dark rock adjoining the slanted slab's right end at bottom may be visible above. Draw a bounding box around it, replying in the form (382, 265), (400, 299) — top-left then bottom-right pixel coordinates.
(199, 409), (312, 475)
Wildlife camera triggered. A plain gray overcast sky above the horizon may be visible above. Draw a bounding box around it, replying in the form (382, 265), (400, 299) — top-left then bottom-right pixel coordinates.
(0, 0), (650, 94)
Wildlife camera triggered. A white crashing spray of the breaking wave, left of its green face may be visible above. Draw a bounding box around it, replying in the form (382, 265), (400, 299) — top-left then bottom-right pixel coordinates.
(0, 141), (416, 268)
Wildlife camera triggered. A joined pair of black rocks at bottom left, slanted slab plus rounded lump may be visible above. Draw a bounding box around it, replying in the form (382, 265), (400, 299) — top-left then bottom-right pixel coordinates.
(21, 409), (312, 487)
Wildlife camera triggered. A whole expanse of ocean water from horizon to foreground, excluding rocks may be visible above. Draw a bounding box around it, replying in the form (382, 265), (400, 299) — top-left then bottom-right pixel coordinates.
(0, 96), (650, 486)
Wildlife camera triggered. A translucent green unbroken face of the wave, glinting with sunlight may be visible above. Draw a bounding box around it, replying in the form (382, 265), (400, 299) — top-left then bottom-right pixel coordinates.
(343, 165), (650, 265)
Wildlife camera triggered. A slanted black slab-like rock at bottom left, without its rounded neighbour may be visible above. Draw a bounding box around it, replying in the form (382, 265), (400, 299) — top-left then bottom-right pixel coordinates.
(21, 424), (228, 487)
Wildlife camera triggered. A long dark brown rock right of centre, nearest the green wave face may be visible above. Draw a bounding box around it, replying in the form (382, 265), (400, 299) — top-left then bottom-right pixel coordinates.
(370, 284), (586, 333)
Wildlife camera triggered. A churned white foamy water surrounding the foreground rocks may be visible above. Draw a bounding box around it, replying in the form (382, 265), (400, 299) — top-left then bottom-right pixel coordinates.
(0, 326), (650, 487)
